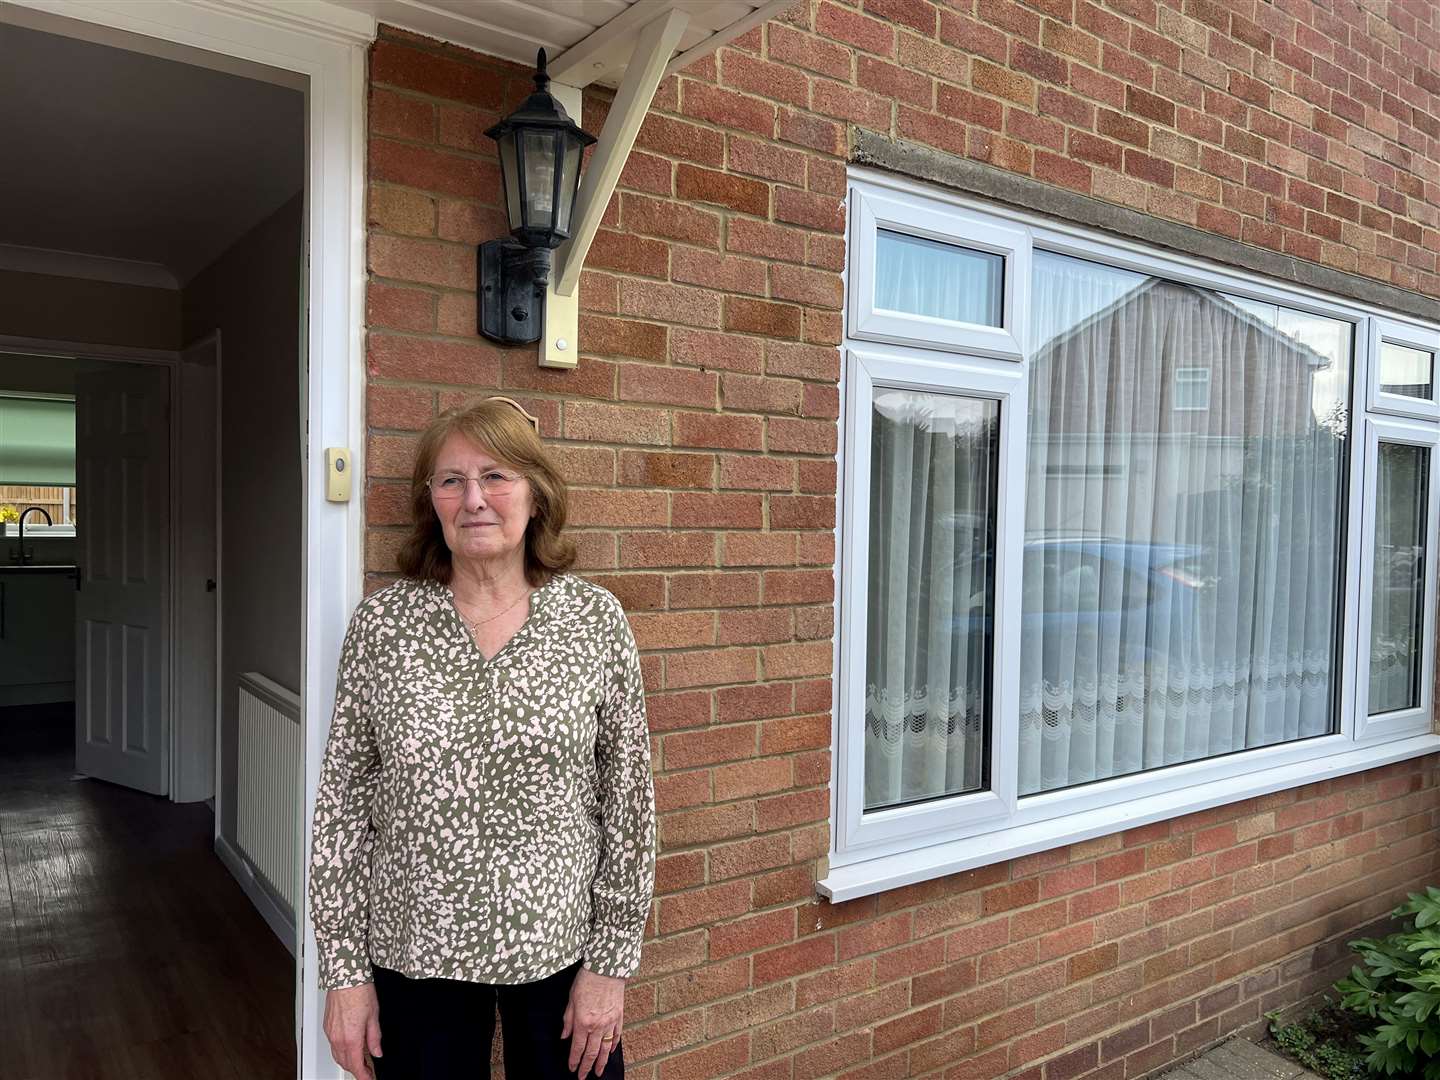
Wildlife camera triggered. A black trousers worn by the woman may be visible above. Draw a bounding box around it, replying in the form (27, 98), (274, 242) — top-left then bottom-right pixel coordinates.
(374, 960), (625, 1080)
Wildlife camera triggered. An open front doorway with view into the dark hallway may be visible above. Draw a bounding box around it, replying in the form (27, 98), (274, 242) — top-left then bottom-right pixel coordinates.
(0, 6), (315, 1077)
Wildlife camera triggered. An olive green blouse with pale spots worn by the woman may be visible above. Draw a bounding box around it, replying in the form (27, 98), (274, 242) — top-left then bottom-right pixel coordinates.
(310, 575), (655, 989)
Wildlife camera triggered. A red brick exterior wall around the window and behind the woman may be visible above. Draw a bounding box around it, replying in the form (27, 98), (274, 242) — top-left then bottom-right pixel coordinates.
(366, 0), (1440, 1080)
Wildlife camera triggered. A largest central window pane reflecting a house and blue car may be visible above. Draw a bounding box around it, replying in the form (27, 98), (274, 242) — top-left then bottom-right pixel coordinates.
(1020, 252), (1352, 793)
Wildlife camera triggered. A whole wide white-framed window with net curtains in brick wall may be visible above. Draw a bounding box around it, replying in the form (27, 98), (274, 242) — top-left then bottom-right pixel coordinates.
(819, 170), (1440, 900)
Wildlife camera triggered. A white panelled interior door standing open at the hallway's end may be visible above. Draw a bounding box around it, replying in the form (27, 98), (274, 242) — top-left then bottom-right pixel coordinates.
(75, 364), (170, 795)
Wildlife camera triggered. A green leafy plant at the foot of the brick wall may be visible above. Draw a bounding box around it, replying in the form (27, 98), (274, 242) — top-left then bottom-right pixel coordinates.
(1335, 886), (1440, 1080)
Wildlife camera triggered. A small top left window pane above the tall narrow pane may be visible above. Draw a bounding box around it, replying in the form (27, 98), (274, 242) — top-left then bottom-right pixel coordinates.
(876, 229), (1005, 327)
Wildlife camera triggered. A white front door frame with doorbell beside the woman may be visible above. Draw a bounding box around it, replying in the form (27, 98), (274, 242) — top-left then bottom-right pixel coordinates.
(9, 0), (376, 1080)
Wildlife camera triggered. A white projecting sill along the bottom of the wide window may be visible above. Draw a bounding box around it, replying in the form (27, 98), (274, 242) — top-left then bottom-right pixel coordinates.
(815, 734), (1440, 903)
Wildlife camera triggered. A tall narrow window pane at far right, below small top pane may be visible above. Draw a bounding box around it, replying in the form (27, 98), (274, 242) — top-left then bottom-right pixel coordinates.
(1369, 442), (1430, 716)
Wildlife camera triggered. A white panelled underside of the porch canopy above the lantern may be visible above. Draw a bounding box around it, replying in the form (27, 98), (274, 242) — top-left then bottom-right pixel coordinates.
(336, 0), (796, 86)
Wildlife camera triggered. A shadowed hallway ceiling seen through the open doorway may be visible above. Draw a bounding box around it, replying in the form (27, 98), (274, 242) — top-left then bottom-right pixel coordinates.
(0, 22), (305, 288)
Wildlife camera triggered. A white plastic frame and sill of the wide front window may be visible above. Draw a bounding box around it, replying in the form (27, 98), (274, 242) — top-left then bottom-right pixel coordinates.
(818, 170), (1440, 901)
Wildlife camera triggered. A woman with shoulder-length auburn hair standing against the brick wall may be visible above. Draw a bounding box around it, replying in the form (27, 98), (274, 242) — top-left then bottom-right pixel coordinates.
(310, 397), (655, 1080)
